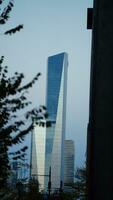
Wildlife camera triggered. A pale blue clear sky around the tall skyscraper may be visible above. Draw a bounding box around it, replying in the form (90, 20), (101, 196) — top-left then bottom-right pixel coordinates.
(0, 0), (93, 167)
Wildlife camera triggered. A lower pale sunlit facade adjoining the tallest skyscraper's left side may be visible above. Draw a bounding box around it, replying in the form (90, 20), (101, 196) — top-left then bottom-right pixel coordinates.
(31, 122), (46, 190)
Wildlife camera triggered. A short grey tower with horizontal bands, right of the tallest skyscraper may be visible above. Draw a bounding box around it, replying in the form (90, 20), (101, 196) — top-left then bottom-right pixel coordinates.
(64, 140), (75, 185)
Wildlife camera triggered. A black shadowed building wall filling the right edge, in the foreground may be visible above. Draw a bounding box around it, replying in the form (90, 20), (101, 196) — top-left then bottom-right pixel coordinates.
(87, 0), (113, 200)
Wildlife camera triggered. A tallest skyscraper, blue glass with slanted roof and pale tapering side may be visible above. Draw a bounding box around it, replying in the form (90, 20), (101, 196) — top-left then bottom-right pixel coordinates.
(45, 53), (68, 189)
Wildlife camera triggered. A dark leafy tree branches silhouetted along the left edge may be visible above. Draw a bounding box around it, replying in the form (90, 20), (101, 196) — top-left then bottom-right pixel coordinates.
(0, 0), (47, 192)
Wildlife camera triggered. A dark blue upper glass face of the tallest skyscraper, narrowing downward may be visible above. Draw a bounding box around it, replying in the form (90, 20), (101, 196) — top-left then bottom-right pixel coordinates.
(46, 53), (64, 121)
